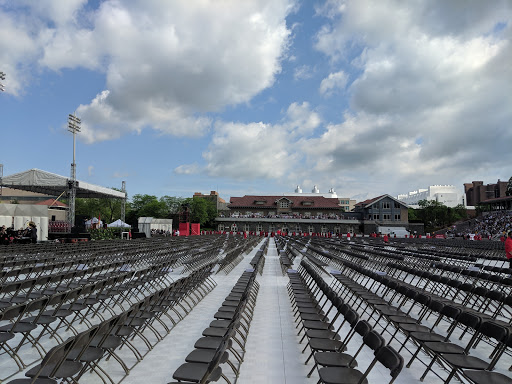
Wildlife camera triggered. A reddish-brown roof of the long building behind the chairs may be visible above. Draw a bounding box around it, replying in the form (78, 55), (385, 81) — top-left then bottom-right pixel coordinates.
(228, 195), (340, 209)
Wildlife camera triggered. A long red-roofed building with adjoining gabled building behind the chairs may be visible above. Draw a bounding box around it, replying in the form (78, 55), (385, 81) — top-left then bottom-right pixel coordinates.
(216, 194), (416, 234)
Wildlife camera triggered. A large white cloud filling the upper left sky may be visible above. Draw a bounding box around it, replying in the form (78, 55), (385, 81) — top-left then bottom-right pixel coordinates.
(0, 0), (294, 142)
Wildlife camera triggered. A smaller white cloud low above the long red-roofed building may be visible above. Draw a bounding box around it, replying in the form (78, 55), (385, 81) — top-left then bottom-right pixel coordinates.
(184, 102), (322, 180)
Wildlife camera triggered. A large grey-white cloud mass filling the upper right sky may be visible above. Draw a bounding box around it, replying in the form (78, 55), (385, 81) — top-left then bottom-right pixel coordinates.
(303, 0), (512, 195)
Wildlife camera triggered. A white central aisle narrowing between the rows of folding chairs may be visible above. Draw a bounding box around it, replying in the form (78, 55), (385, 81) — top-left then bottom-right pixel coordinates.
(238, 238), (310, 384)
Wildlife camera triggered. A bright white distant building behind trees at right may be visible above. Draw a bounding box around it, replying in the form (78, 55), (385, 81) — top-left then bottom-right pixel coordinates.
(397, 185), (464, 208)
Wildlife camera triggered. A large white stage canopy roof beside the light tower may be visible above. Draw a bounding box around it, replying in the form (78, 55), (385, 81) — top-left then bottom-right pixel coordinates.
(1, 168), (126, 199)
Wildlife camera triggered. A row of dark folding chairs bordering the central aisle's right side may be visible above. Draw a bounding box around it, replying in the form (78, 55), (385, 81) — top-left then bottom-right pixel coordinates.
(288, 261), (403, 384)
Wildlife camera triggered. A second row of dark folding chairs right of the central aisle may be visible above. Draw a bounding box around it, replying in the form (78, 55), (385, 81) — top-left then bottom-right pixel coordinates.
(328, 264), (512, 384)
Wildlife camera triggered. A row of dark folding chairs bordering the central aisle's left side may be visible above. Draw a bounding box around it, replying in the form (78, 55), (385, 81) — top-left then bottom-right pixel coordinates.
(170, 264), (263, 384)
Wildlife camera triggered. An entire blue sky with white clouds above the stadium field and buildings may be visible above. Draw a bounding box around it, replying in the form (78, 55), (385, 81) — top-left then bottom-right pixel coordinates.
(0, 0), (512, 201)
